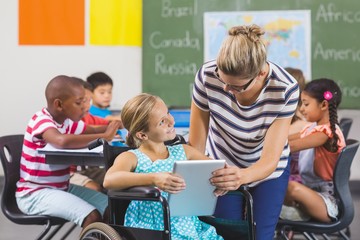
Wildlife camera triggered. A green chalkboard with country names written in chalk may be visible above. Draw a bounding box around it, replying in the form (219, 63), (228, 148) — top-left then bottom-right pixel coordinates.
(142, 0), (360, 109)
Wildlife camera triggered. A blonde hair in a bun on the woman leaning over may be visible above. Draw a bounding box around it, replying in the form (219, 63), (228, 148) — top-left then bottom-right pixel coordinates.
(216, 24), (266, 79)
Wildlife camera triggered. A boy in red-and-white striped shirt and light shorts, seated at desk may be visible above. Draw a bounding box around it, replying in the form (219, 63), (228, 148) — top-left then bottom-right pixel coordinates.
(16, 75), (120, 227)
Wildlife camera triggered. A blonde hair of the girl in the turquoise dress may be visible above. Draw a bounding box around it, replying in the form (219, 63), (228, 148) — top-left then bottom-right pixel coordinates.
(121, 93), (161, 148)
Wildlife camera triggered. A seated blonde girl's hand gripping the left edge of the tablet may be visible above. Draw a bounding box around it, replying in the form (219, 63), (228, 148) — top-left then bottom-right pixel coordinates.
(155, 172), (186, 193)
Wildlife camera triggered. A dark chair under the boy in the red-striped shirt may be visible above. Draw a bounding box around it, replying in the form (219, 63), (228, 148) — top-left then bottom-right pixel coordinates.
(0, 135), (76, 239)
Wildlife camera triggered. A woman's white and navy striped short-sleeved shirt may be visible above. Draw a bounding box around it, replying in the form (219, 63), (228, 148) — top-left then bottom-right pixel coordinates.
(193, 61), (299, 184)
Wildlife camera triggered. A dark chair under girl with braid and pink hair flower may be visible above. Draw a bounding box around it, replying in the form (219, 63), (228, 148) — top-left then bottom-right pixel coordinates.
(277, 139), (359, 240)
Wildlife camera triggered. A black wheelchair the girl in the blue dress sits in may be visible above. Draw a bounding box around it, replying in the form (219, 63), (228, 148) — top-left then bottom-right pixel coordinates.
(80, 135), (255, 240)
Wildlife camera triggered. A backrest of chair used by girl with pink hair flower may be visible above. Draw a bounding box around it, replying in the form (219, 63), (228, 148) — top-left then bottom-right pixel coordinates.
(334, 139), (359, 228)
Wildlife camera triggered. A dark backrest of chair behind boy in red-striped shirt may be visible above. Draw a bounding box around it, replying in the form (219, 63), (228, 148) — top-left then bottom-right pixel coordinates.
(0, 134), (24, 219)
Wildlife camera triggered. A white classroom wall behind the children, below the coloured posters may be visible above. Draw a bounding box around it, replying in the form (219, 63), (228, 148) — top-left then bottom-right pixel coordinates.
(0, 1), (360, 180)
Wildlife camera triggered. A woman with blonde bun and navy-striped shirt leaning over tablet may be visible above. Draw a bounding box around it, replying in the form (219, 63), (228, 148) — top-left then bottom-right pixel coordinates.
(189, 25), (299, 240)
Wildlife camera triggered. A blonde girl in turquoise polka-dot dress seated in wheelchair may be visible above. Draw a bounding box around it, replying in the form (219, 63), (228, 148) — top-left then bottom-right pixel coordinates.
(104, 93), (226, 240)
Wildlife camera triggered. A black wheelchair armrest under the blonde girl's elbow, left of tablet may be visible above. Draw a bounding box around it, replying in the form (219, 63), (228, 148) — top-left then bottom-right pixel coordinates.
(107, 186), (161, 201)
